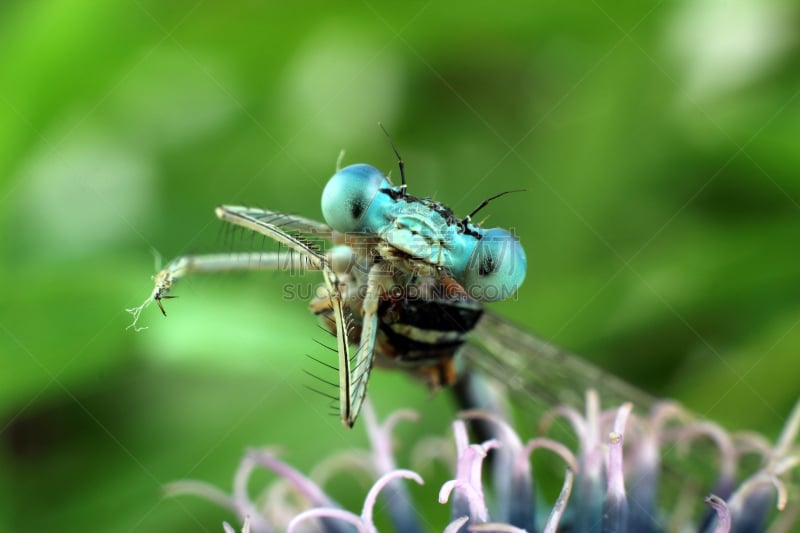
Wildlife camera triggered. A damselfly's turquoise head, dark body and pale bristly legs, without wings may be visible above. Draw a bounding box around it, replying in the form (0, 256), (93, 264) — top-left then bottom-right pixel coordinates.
(132, 156), (526, 427)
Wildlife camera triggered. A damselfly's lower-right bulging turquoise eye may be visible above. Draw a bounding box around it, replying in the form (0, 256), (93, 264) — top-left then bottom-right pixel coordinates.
(463, 228), (528, 302)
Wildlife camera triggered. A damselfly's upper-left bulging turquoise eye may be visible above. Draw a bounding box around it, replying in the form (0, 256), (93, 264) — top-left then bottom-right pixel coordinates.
(322, 164), (392, 233)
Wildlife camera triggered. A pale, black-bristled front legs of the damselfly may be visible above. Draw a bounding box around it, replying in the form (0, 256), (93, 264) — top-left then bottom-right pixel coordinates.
(130, 206), (392, 427)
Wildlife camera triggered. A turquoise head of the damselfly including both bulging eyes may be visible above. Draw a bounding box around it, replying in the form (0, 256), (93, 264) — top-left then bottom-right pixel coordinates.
(322, 164), (527, 301)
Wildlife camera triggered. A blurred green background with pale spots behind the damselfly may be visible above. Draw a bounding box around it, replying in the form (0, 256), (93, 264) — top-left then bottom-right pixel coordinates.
(0, 0), (800, 531)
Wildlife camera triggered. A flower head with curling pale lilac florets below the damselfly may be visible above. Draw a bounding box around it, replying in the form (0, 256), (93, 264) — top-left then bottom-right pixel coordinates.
(169, 391), (800, 533)
